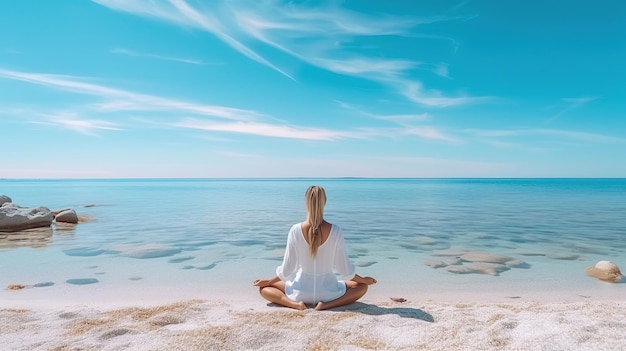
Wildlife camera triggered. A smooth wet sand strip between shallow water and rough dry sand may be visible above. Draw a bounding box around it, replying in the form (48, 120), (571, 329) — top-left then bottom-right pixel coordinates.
(0, 277), (626, 308)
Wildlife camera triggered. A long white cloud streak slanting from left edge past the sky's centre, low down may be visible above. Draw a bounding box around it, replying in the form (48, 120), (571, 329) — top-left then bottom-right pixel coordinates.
(0, 69), (472, 143)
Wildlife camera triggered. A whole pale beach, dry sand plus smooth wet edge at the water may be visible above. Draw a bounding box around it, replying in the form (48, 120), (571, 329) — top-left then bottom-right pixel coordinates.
(0, 261), (626, 351)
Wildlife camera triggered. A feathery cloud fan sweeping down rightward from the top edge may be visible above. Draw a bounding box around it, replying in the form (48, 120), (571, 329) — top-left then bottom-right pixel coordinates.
(93, 0), (492, 107)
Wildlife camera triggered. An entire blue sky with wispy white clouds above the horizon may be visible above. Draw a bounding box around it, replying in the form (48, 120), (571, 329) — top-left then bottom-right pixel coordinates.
(0, 0), (626, 178)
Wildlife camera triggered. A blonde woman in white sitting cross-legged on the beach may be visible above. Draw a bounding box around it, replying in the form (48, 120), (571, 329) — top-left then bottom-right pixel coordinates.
(253, 186), (376, 310)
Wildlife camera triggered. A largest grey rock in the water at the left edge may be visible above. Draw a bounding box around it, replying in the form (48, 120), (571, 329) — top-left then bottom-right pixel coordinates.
(0, 202), (53, 232)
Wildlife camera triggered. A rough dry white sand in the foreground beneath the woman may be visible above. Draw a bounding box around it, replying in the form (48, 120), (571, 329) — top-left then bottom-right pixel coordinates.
(0, 289), (626, 350)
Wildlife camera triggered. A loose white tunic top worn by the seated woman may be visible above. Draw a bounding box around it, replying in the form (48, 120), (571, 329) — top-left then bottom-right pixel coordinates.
(276, 223), (355, 304)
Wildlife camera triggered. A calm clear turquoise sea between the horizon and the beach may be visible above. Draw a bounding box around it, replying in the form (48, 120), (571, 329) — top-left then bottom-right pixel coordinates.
(0, 178), (626, 301)
